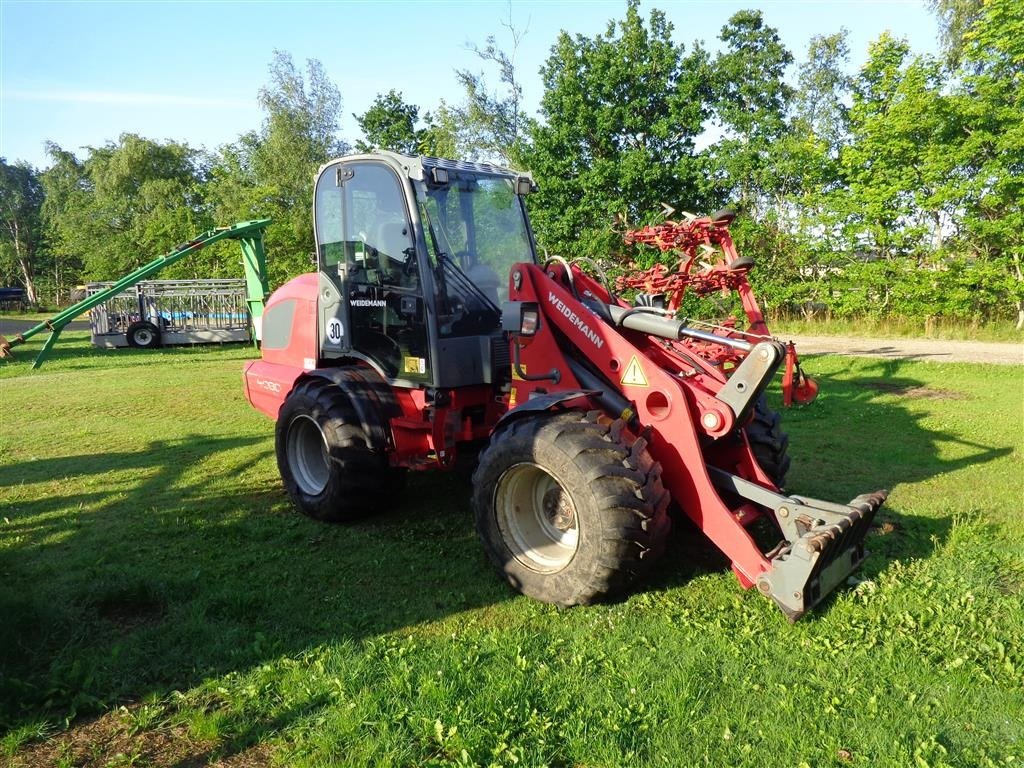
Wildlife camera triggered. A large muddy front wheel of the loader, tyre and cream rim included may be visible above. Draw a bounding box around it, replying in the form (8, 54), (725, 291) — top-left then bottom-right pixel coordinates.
(473, 412), (672, 607)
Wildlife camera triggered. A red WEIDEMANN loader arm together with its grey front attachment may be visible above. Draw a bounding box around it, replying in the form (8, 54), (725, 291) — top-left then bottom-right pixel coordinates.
(510, 263), (886, 620)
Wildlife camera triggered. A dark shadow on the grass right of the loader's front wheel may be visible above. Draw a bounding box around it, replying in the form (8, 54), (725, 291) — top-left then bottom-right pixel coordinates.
(652, 359), (1013, 593)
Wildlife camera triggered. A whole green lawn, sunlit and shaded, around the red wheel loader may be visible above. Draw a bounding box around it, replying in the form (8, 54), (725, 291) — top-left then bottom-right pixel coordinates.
(0, 334), (1024, 768)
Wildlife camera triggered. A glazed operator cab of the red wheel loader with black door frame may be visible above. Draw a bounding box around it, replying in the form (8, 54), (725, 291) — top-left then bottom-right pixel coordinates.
(314, 153), (537, 387)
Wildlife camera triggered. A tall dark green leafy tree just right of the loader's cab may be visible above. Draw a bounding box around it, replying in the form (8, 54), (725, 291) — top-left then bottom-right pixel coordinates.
(525, 1), (710, 257)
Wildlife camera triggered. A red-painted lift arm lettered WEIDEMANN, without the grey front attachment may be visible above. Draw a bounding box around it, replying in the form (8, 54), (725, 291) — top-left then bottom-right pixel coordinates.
(511, 264), (777, 588)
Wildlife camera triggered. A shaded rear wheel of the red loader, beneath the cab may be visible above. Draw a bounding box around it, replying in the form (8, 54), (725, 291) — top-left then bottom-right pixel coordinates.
(274, 379), (401, 522)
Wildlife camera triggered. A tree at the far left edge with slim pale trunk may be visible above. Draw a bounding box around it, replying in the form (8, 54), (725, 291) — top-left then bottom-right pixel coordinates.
(0, 158), (43, 304)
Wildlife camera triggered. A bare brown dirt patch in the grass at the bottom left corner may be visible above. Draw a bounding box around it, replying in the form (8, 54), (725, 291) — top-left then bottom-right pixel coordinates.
(9, 706), (272, 768)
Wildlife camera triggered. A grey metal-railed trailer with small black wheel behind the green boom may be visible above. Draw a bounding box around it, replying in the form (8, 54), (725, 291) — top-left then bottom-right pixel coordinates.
(85, 279), (258, 349)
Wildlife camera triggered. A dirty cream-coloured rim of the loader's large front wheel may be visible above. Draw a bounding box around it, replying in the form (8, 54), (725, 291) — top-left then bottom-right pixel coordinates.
(495, 463), (580, 573)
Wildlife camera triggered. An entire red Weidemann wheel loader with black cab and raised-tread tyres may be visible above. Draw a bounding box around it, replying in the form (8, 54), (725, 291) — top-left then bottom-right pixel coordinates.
(244, 153), (886, 620)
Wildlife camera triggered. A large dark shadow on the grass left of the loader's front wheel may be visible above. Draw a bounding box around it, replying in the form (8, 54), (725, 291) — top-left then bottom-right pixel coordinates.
(0, 435), (503, 746)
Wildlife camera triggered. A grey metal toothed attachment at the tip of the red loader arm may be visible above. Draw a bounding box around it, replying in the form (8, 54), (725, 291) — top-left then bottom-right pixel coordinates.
(709, 467), (889, 622)
